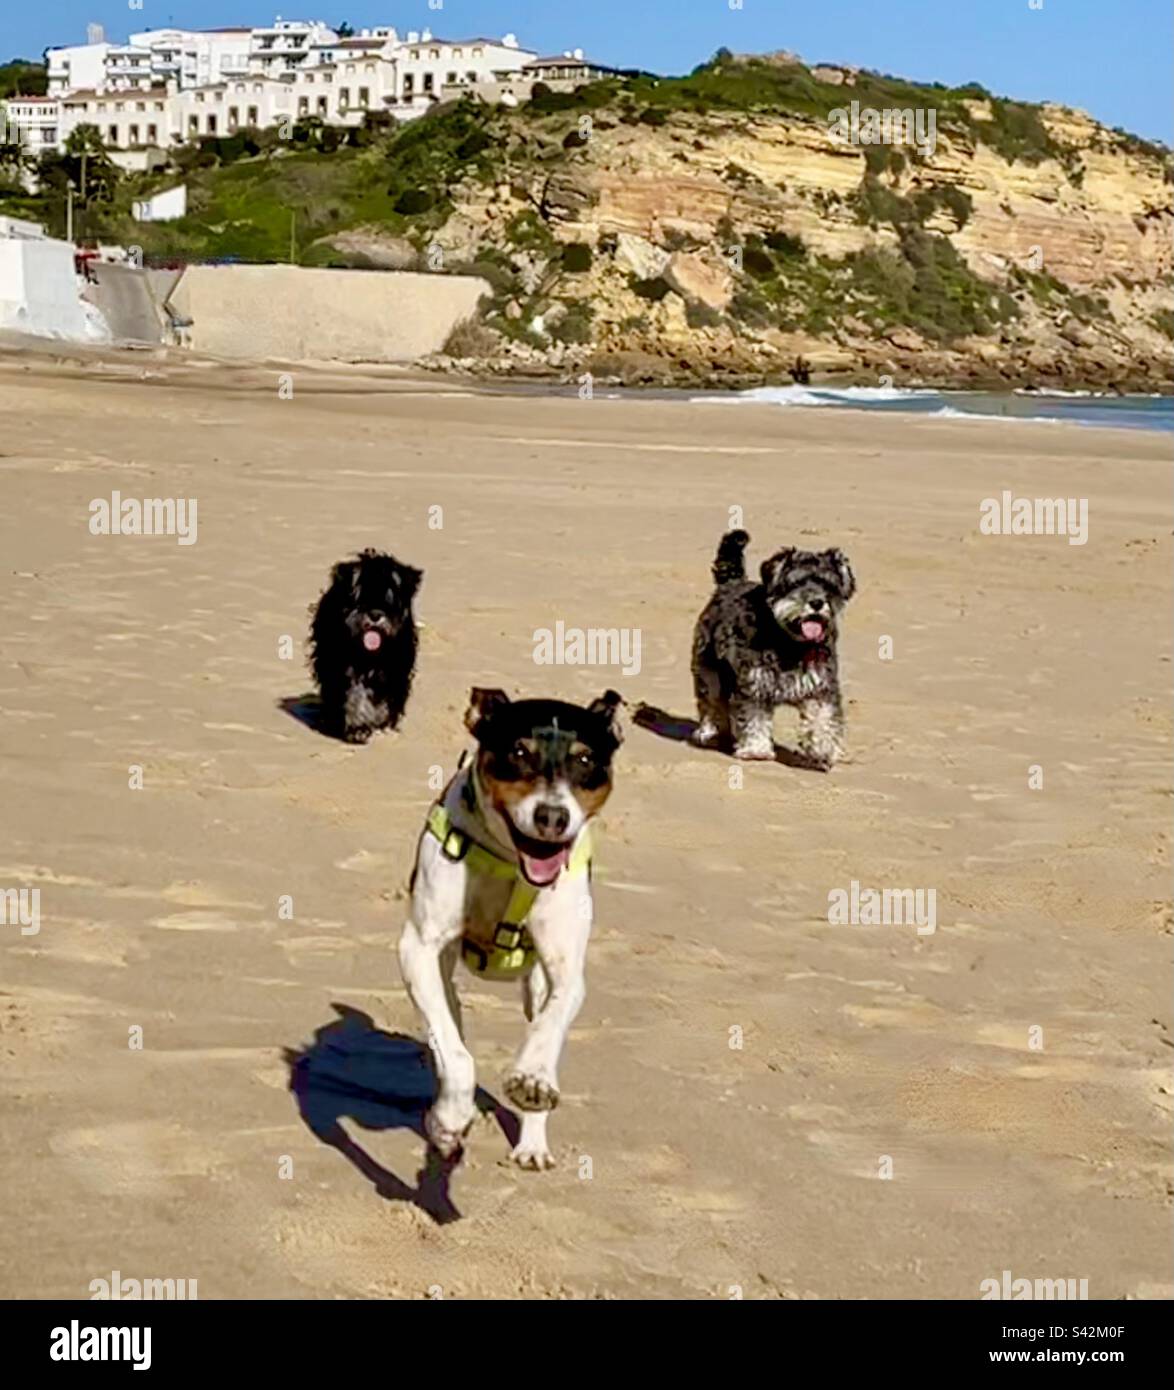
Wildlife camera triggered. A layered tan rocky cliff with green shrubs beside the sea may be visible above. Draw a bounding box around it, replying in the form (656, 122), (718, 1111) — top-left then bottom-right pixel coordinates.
(383, 56), (1174, 389)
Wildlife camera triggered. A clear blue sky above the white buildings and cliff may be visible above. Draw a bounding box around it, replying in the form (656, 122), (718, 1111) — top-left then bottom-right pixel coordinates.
(0, 0), (1174, 143)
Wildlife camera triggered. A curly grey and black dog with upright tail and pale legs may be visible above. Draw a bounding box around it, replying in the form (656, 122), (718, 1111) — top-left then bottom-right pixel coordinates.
(693, 531), (856, 769)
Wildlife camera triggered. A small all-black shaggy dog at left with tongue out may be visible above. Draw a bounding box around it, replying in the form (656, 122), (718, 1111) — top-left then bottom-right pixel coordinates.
(310, 550), (424, 744)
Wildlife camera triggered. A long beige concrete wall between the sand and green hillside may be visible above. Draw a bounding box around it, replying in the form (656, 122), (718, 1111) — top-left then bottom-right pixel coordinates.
(170, 265), (489, 361)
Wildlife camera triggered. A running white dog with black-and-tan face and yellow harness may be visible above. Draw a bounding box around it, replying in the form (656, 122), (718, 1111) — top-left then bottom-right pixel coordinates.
(399, 688), (622, 1169)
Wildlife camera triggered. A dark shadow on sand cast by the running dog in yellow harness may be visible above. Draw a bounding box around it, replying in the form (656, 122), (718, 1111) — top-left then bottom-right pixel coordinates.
(285, 1004), (521, 1226)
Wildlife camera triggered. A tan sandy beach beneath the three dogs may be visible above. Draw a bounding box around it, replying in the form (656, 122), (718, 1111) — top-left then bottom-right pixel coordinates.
(0, 356), (1174, 1300)
